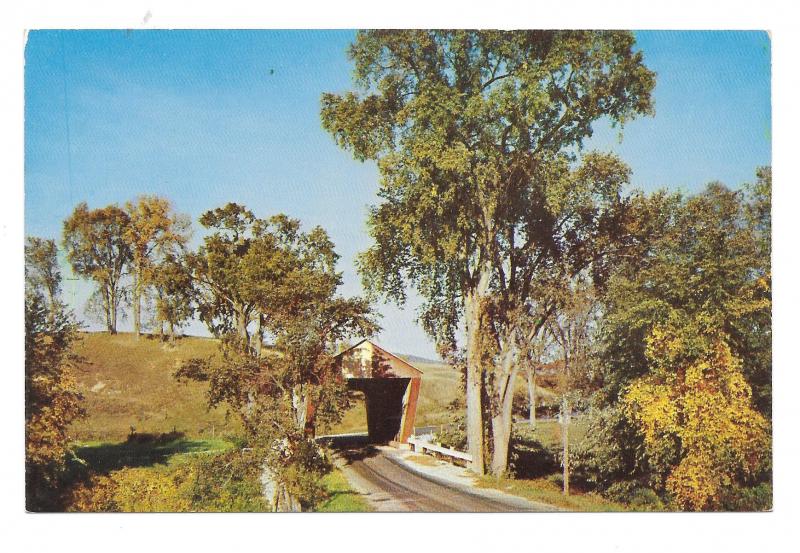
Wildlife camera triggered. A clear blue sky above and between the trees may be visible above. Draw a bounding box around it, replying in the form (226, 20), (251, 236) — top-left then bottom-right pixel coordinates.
(25, 31), (771, 356)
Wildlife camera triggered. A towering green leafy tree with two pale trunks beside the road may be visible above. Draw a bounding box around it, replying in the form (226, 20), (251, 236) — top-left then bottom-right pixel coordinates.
(322, 31), (654, 473)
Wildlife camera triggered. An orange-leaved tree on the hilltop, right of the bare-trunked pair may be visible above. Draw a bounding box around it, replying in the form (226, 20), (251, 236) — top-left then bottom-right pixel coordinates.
(124, 196), (194, 338)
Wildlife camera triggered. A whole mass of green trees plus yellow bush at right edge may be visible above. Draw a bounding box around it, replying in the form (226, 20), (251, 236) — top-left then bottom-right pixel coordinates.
(578, 168), (772, 509)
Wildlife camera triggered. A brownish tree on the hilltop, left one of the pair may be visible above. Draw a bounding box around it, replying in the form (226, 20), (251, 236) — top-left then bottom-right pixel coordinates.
(63, 202), (131, 334)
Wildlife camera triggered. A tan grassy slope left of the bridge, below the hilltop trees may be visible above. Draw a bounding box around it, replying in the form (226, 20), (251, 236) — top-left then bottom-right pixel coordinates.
(71, 333), (238, 442)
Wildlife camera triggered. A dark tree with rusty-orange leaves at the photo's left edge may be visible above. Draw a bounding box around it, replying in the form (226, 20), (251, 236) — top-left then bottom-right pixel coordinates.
(25, 238), (83, 511)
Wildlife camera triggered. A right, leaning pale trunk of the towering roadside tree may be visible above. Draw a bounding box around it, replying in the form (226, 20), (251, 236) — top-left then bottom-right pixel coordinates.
(492, 340), (517, 478)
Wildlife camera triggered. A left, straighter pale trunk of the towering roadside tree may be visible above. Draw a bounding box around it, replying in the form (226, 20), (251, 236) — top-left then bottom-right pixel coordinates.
(465, 288), (486, 474)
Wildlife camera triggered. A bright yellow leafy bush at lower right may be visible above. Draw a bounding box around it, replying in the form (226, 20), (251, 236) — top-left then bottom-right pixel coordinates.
(623, 327), (770, 510)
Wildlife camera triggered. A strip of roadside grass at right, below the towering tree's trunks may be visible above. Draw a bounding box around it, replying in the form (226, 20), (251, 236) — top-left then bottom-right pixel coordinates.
(478, 476), (629, 512)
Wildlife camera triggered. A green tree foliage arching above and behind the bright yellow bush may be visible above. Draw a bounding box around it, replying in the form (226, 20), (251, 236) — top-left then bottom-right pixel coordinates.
(602, 175), (771, 415)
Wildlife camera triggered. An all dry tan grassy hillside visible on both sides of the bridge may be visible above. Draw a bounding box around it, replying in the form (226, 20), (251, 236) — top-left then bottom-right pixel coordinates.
(72, 333), (552, 442)
